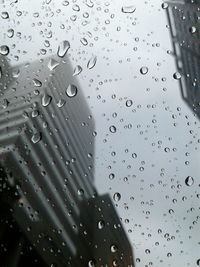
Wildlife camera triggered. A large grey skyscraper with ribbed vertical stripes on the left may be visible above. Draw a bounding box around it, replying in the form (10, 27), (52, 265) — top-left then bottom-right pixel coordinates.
(0, 55), (133, 267)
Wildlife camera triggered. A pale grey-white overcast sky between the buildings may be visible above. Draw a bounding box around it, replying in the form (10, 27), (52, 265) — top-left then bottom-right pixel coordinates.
(0, 0), (200, 267)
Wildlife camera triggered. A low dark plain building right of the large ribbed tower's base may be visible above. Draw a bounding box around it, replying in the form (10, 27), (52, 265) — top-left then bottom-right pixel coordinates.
(92, 194), (134, 267)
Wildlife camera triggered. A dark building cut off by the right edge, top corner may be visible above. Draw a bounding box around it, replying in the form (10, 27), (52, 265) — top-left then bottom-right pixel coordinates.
(166, 0), (200, 117)
